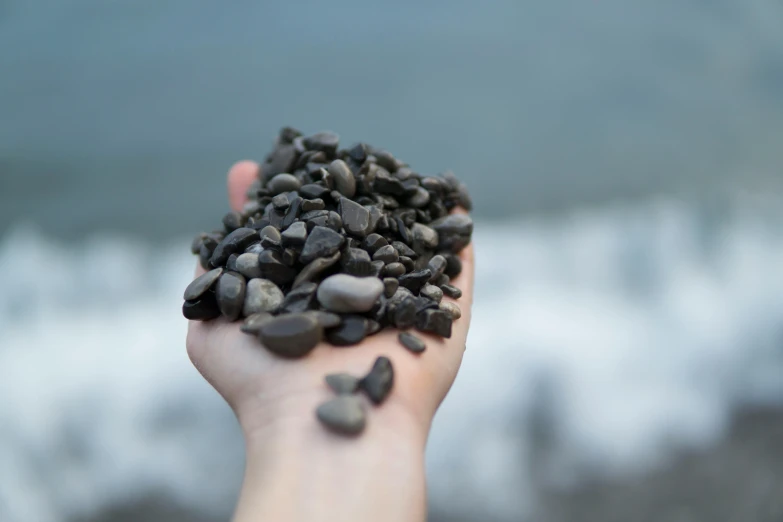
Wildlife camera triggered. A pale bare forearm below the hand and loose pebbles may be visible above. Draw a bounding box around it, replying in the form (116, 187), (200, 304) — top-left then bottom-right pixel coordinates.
(234, 398), (426, 522)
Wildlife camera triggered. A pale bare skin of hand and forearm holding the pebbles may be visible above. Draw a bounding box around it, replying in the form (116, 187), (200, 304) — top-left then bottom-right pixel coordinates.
(187, 161), (473, 522)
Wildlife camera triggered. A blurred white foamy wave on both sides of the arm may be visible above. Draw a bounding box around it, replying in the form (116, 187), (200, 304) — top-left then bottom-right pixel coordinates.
(0, 195), (783, 522)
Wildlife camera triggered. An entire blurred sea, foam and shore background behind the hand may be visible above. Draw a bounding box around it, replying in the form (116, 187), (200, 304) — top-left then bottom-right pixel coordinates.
(0, 0), (783, 522)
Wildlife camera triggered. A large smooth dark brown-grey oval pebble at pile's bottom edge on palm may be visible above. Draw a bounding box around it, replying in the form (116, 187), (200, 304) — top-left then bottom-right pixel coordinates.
(258, 314), (323, 358)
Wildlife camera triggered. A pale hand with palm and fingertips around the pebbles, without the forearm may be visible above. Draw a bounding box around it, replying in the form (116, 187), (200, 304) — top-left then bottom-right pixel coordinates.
(187, 162), (473, 432)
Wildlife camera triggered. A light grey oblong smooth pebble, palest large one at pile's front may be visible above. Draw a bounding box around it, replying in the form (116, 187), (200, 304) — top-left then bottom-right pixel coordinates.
(318, 274), (384, 313)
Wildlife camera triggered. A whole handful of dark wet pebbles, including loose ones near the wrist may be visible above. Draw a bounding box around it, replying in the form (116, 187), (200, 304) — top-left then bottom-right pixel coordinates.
(187, 127), (473, 435)
